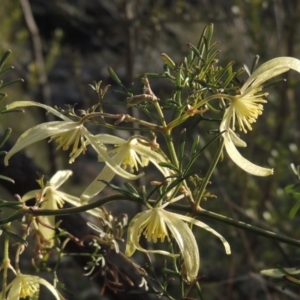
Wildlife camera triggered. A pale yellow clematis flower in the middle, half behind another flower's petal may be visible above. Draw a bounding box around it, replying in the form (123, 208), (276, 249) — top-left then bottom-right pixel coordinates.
(81, 134), (171, 202)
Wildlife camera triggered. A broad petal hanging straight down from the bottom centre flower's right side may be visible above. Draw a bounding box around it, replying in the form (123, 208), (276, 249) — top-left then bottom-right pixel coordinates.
(160, 210), (200, 282)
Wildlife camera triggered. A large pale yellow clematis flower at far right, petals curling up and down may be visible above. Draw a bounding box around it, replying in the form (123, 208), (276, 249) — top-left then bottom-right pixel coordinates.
(220, 57), (300, 176)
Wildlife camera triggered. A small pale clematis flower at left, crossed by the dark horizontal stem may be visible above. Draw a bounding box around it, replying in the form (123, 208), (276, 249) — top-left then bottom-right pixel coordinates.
(21, 170), (80, 247)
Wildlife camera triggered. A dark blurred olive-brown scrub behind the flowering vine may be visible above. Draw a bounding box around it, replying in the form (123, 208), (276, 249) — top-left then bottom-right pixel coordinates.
(0, 0), (300, 300)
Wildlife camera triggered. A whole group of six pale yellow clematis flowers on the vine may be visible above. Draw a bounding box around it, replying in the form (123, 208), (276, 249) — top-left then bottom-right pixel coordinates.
(4, 57), (300, 292)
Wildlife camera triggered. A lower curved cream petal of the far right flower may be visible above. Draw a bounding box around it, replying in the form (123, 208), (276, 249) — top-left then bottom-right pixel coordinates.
(223, 132), (273, 176)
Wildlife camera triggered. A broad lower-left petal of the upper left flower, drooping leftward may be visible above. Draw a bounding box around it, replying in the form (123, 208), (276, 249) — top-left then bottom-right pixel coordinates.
(4, 121), (79, 166)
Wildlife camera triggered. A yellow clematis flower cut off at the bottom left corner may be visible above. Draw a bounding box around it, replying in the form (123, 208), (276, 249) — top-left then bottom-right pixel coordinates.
(1, 273), (63, 300)
